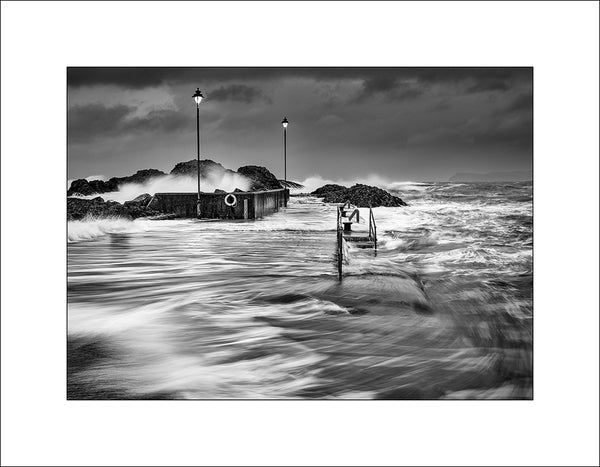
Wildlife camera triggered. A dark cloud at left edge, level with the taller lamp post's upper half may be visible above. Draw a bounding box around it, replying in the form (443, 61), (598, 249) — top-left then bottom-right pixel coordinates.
(67, 104), (190, 143)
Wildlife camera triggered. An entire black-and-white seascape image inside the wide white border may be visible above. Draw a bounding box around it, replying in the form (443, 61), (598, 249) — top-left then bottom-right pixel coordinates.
(67, 67), (534, 399)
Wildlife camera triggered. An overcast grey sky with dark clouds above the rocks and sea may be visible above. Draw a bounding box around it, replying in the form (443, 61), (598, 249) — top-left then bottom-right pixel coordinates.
(67, 68), (533, 181)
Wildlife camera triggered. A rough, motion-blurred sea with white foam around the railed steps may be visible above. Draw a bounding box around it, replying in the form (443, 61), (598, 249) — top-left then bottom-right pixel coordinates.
(67, 182), (533, 400)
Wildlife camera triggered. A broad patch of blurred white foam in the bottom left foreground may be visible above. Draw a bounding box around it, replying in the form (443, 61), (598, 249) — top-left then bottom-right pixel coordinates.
(69, 297), (324, 398)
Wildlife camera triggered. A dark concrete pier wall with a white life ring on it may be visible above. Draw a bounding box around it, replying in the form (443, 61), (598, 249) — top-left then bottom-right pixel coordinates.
(149, 188), (290, 219)
